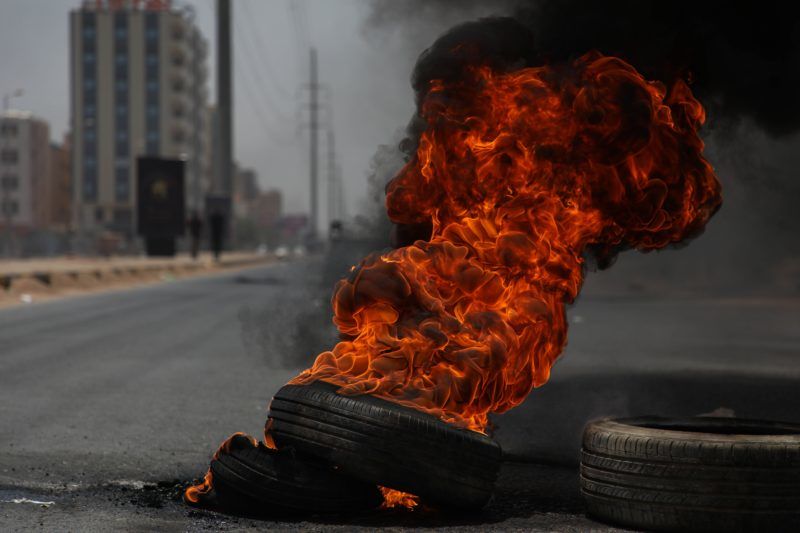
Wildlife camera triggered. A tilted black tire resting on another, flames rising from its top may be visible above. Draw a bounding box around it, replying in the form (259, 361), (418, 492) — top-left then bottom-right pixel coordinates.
(268, 381), (501, 510)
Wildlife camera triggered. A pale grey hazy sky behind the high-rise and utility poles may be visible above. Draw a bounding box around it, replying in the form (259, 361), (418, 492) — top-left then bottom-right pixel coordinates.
(0, 0), (462, 218)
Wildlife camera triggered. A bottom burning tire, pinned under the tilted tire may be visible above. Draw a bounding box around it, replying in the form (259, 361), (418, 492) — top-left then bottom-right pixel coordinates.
(206, 436), (383, 515)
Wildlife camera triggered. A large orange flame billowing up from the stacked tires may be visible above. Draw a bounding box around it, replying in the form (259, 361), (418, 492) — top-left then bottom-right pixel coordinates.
(292, 53), (721, 431)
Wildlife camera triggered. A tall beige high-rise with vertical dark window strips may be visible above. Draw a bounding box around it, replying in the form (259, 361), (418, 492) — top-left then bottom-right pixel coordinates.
(70, 0), (211, 236)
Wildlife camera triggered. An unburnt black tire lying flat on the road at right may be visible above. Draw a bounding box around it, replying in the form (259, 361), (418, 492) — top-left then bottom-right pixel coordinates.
(581, 417), (800, 532)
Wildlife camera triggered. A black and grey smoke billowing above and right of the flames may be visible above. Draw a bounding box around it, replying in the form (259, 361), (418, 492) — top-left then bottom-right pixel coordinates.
(367, 0), (800, 292)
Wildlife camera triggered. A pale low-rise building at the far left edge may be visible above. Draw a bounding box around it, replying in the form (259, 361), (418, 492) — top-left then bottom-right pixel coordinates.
(0, 111), (53, 232)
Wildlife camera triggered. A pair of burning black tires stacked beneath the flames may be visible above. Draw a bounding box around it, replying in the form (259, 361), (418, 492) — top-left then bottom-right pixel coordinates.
(211, 381), (501, 513)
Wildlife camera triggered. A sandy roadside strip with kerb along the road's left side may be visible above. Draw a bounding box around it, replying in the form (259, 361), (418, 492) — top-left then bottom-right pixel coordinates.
(0, 252), (275, 307)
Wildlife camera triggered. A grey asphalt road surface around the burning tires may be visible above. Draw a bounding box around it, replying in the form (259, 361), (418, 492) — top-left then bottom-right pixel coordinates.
(0, 259), (800, 531)
